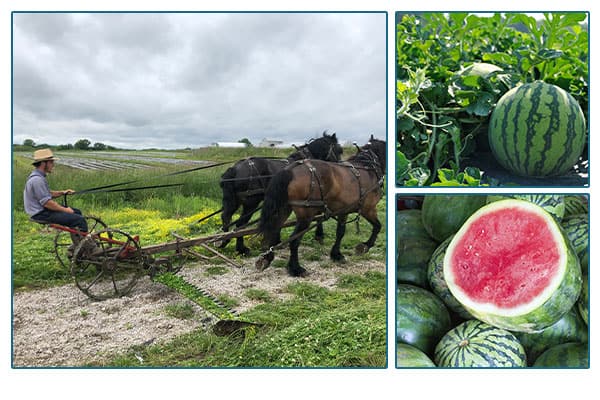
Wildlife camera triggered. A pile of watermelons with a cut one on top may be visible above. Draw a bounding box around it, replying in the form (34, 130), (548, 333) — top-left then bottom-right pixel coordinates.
(396, 194), (589, 368)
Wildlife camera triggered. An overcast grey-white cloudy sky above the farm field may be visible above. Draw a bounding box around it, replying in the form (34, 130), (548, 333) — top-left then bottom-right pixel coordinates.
(13, 13), (386, 149)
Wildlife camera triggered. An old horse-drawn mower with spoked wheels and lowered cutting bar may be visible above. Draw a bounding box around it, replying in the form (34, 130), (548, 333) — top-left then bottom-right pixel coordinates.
(41, 216), (268, 334)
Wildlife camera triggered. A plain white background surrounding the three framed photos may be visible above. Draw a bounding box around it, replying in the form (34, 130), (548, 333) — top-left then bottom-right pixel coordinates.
(0, 0), (600, 400)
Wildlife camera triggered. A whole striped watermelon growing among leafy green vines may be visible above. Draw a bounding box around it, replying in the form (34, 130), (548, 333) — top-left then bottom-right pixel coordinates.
(488, 81), (587, 177)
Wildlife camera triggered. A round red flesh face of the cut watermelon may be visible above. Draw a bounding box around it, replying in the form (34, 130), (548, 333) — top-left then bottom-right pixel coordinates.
(452, 207), (561, 309)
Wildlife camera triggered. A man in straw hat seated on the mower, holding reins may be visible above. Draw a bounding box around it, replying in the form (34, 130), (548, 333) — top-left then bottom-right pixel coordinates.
(23, 149), (88, 239)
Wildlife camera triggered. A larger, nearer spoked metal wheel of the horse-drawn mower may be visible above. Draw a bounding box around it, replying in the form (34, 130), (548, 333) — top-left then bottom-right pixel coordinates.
(71, 229), (146, 300)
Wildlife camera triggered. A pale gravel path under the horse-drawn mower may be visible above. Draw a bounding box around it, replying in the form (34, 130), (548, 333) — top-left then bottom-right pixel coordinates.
(12, 261), (385, 367)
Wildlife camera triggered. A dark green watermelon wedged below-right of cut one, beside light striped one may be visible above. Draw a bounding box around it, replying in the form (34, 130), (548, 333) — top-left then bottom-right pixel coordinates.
(515, 307), (588, 364)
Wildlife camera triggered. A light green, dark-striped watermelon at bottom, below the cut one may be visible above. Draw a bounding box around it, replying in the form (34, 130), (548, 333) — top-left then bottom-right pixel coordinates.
(434, 319), (527, 368)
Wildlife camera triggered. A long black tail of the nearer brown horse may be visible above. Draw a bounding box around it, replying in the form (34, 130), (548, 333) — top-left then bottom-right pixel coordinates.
(258, 169), (293, 246)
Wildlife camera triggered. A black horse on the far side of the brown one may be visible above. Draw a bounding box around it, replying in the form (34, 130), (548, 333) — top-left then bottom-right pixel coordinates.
(220, 132), (343, 256)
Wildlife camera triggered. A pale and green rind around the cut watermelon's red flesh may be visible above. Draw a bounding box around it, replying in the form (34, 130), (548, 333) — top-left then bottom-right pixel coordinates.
(444, 199), (582, 332)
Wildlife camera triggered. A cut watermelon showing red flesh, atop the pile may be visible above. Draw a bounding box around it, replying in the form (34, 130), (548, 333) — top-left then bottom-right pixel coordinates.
(444, 199), (581, 332)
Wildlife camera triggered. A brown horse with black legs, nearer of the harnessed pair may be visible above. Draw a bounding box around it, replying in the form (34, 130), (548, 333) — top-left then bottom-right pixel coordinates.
(256, 135), (386, 276)
